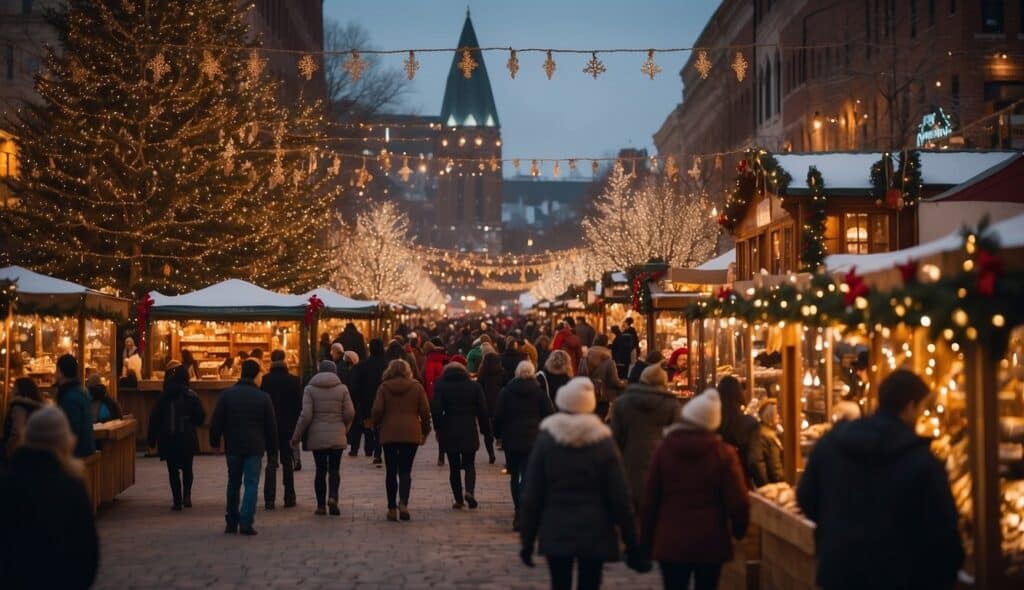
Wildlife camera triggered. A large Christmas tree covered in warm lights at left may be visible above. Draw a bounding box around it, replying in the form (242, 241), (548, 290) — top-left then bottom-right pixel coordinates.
(0, 0), (337, 294)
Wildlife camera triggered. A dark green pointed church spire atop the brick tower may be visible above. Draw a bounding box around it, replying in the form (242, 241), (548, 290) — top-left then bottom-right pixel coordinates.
(441, 6), (501, 127)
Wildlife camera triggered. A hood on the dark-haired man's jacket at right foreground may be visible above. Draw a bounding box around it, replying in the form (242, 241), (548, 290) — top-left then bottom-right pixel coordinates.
(831, 412), (928, 461)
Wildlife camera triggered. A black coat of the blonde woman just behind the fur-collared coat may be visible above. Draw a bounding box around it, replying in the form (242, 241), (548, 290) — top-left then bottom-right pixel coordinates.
(494, 378), (555, 453)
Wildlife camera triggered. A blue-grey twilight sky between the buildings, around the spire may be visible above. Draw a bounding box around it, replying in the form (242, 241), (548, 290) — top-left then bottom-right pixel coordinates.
(324, 0), (718, 175)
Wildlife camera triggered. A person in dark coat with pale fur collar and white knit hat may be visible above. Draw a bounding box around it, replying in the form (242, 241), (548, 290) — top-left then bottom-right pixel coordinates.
(519, 377), (650, 590)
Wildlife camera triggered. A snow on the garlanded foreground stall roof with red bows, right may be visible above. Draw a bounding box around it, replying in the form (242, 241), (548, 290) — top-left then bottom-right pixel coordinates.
(825, 214), (1024, 275)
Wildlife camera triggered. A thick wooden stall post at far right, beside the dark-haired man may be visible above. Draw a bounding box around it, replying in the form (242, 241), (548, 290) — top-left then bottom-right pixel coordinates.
(964, 342), (1006, 588)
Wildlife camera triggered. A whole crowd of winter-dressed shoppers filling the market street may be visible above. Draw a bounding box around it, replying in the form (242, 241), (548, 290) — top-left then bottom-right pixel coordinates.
(0, 318), (964, 590)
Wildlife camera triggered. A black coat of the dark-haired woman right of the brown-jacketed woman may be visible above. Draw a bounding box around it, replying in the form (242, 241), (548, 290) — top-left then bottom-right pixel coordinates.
(430, 366), (490, 453)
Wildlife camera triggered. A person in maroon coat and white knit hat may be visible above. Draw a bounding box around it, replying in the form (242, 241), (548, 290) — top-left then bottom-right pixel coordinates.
(641, 389), (751, 590)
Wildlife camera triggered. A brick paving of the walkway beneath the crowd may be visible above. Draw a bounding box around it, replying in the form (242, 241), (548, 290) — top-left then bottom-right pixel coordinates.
(96, 436), (660, 590)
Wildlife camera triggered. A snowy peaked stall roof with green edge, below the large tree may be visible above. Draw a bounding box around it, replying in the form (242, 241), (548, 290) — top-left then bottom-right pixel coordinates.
(150, 279), (306, 320)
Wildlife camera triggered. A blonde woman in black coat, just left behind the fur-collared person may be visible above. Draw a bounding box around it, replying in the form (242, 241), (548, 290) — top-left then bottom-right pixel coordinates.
(495, 361), (555, 531)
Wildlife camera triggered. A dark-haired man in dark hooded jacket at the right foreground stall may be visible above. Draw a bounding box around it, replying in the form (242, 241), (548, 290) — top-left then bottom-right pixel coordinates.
(797, 369), (964, 590)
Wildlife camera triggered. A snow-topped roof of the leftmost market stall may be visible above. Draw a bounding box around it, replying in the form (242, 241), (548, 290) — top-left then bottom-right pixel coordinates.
(0, 266), (131, 321)
